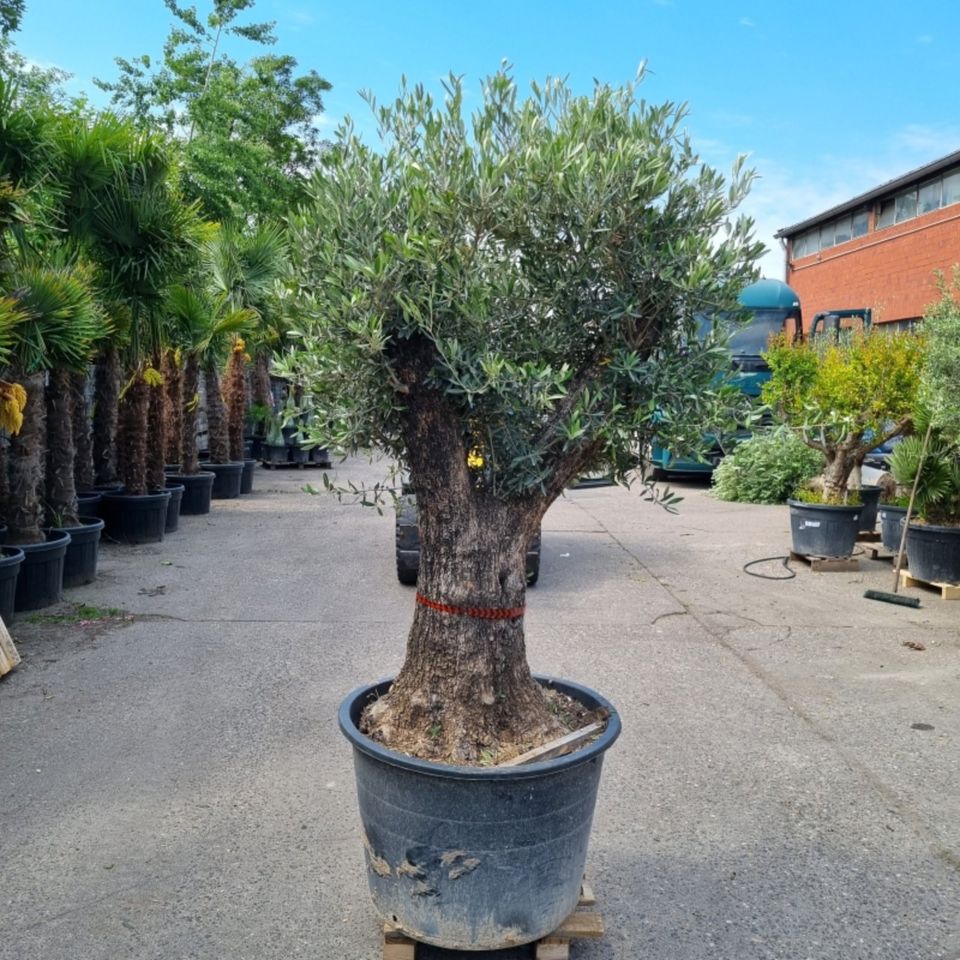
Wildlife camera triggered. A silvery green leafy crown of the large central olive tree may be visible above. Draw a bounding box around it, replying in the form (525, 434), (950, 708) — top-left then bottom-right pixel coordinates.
(274, 70), (762, 497)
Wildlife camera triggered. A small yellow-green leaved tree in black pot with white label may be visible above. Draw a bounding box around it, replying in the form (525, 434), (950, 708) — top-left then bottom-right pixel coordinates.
(762, 328), (924, 557)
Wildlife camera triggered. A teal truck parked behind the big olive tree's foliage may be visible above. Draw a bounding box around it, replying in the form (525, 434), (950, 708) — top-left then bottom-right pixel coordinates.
(650, 280), (804, 479)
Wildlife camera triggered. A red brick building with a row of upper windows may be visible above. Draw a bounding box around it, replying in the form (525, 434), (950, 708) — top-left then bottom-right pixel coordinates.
(777, 151), (960, 327)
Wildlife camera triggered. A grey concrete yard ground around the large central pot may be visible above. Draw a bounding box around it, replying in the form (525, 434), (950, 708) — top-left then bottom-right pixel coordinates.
(0, 460), (960, 960)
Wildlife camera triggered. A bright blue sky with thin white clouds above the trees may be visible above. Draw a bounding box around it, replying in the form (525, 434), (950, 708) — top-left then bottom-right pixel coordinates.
(16, 0), (960, 277)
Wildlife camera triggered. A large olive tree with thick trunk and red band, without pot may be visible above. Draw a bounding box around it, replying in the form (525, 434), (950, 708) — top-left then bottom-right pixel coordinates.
(275, 71), (762, 762)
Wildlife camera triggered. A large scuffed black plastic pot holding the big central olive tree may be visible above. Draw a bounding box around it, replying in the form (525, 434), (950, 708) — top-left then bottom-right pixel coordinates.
(340, 677), (620, 950)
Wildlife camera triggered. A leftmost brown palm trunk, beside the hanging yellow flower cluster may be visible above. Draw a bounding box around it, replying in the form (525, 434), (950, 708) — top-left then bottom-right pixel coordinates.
(7, 373), (46, 543)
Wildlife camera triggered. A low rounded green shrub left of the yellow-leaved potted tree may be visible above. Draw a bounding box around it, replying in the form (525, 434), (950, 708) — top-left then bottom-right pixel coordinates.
(713, 427), (824, 503)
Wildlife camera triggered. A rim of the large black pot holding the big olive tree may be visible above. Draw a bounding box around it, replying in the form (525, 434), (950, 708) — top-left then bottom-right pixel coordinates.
(338, 673), (621, 780)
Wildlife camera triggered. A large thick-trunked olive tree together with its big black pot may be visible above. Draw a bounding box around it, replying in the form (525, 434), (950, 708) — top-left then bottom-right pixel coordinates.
(275, 72), (761, 949)
